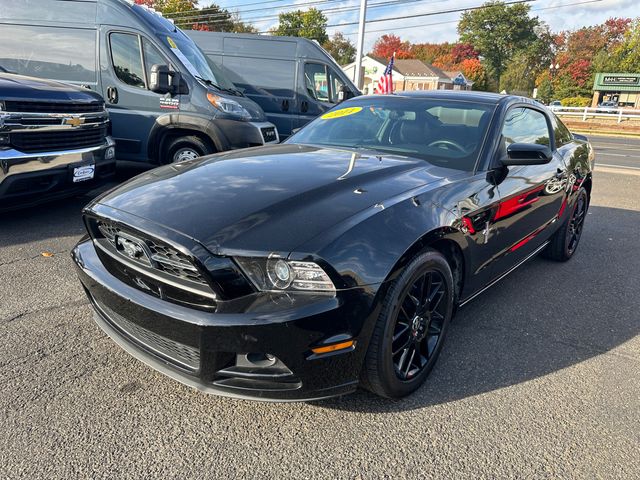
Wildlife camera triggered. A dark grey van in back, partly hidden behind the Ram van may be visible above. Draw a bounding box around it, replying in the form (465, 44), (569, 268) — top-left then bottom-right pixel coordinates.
(187, 31), (360, 139)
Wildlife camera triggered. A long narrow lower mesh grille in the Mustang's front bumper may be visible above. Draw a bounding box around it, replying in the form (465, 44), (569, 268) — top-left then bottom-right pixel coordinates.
(94, 299), (200, 371)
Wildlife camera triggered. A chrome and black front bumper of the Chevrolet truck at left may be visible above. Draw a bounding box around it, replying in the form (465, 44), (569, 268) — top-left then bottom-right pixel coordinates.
(0, 137), (116, 210)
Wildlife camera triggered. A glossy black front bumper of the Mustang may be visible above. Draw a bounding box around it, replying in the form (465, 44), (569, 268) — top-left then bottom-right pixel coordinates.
(72, 238), (374, 401)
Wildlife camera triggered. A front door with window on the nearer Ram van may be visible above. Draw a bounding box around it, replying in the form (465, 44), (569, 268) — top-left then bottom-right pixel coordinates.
(100, 27), (172, 161)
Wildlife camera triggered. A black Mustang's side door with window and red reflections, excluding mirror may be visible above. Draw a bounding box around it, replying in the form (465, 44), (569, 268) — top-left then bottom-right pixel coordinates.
(493, 105), (567, 274)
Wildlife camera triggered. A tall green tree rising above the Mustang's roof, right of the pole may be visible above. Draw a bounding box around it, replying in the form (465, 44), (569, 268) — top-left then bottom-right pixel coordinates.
(458, 1), (540, 86)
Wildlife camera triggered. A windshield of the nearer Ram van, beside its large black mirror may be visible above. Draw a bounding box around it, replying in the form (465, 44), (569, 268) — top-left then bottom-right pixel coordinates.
(160, 32), (238, 92)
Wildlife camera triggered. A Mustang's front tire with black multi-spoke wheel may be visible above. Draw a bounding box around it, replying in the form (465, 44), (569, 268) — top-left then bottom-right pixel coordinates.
(362, 250), (454, 398)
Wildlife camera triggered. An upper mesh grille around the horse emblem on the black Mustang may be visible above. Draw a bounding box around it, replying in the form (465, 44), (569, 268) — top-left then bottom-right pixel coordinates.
(98, 220), (208, 285)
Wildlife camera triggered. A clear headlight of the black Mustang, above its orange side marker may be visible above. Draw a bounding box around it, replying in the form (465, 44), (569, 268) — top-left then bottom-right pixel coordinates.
(235, 257), (336, 292)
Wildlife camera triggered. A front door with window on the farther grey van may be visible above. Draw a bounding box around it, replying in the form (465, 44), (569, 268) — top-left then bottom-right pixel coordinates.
(296, 62), (344, 128)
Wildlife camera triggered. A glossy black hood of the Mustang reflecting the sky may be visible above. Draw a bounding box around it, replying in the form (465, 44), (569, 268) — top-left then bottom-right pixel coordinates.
(98, 144), (456, 254)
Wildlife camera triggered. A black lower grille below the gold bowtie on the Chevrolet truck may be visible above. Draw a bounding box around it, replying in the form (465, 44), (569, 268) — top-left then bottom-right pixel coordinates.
(10, 125), (107, 153)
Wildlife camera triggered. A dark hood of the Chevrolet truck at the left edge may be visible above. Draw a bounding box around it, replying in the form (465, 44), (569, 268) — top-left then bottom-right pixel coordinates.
(0, 73), (102, 102)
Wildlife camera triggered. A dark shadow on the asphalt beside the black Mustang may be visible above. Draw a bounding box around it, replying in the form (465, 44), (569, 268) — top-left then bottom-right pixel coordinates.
(315, 207), (640, 413)
